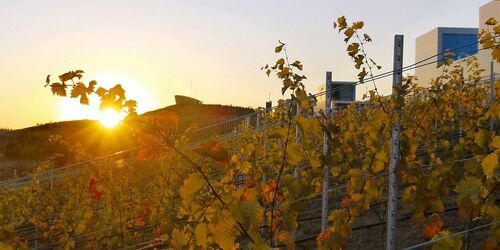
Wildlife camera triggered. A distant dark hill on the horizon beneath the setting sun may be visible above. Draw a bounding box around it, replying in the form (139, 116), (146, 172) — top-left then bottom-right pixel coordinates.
(0, 96), (253, 179)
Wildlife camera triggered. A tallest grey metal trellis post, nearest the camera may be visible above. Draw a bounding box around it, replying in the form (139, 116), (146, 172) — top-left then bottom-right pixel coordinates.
(386, 35), (404, 250)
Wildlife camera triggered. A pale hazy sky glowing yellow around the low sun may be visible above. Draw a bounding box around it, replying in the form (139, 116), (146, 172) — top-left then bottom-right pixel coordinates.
(0, 0), (488, 128)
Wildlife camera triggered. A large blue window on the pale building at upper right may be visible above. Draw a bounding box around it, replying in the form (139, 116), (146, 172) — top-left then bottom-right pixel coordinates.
(440, 33), (478, 60)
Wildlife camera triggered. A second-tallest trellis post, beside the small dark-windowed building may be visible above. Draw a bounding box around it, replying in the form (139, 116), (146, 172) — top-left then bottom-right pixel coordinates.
(321, 71), (332, 231)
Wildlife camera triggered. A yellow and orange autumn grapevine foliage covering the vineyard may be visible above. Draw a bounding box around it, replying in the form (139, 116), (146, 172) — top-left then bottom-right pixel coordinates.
(0, 17), (500, 249)
